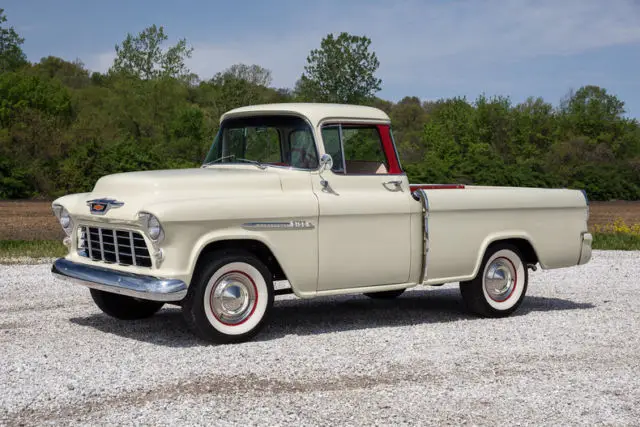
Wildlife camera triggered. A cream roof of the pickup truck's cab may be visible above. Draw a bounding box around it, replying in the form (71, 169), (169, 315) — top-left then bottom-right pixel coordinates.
(220, 103), (391, 126)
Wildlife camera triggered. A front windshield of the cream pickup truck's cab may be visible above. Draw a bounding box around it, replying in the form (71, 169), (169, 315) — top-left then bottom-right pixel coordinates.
(203, 116), (318, 169)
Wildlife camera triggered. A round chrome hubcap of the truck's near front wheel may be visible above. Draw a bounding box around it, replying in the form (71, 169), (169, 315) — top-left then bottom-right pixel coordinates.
(210, 271), (256, 324)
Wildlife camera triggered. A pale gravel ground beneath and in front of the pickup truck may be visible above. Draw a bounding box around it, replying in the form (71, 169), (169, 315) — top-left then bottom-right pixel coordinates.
(0, 252), (640, 425)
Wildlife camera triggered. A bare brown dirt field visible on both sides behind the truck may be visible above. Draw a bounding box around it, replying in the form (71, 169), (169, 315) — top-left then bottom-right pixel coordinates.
(0, 200), (640, 240)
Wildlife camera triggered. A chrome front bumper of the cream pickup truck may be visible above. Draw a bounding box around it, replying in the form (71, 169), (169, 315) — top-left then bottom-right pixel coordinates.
(51, 258), (187, 302)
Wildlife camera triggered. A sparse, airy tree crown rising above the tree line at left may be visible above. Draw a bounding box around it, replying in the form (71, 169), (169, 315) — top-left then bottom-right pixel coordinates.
(111, 24), (193, 80)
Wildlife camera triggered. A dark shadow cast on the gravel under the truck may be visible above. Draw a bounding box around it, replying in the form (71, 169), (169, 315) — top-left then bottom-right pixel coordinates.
(70, 289), (595, 347)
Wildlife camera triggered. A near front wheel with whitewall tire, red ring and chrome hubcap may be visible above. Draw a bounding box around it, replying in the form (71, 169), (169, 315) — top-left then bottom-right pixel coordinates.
(182, 251), (273, 343)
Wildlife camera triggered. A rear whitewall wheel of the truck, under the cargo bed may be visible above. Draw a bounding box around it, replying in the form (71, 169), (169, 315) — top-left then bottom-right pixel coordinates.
(460, 244), (529, 317)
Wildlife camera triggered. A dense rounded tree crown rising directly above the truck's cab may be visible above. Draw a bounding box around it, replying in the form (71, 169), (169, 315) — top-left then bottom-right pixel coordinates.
(296, 33), (382, 104)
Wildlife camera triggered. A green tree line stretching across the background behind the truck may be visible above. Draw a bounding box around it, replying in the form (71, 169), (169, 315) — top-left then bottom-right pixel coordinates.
(0, 9), (640, 200)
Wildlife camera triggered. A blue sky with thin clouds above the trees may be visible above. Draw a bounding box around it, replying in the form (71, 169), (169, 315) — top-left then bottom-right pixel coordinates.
(2, 0), (640, 118)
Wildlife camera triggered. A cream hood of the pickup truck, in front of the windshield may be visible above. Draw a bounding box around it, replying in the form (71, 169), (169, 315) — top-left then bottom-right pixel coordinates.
(54, 165), (282, 220)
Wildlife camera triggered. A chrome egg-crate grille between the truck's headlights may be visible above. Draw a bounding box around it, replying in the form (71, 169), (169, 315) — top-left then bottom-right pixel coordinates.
(78, 225), (151, 267)
